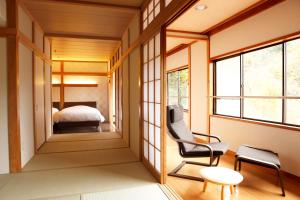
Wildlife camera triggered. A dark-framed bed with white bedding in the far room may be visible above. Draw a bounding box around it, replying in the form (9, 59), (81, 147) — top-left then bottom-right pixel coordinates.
(52, 102), (105, 131)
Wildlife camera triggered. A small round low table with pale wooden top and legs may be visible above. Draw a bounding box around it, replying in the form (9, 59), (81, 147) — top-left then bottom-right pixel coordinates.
(200, 167), (243, 200)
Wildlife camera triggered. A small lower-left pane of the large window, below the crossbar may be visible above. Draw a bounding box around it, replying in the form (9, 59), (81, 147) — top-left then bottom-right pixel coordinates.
(216, 99), (240, 117)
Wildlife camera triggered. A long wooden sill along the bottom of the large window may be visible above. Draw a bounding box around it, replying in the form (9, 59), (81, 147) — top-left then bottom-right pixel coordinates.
(210, 115), (300, 131)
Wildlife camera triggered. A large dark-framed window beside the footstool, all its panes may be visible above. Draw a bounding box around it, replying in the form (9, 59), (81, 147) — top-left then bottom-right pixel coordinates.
(214, 39), (300, 126)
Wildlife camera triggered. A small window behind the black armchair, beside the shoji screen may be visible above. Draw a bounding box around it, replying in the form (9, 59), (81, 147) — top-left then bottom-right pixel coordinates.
(168, 68), (189, 110)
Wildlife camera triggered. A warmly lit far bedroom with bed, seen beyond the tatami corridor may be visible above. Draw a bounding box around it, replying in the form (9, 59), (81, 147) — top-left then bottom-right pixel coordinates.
(35, 38), (128, 153)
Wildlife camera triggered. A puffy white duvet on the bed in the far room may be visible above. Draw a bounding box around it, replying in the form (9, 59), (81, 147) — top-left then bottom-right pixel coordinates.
(54, 106), (105, 122)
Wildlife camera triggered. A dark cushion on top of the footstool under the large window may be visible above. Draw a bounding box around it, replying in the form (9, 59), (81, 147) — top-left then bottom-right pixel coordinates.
(236, 145), (280, 167)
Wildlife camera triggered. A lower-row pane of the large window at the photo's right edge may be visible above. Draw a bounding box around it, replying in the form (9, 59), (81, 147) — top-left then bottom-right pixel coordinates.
(285, 99), (300, 125)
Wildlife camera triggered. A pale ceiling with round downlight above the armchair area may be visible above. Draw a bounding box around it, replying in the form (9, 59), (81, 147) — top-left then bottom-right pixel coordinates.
(168, 0), (261, 33)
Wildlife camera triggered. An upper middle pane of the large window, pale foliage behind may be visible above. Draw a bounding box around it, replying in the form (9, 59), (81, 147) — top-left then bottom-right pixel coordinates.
(243, 44), (283, 96)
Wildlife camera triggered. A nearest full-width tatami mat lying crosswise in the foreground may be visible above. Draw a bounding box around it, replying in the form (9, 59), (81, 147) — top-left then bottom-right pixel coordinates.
(0, 162), (156, 200)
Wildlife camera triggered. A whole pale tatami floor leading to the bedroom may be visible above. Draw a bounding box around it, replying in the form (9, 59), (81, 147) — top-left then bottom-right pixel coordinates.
(0, 135), (167, 200)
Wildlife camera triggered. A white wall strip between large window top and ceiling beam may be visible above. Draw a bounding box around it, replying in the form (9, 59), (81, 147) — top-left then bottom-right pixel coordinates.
(210, 0), (300, 57)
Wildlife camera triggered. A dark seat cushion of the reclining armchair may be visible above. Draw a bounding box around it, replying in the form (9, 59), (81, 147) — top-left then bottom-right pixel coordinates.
(185, 142), (228, 157)
